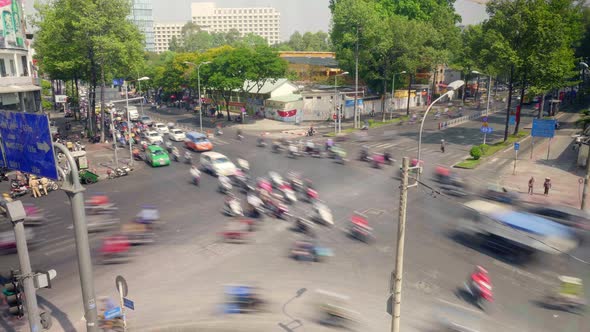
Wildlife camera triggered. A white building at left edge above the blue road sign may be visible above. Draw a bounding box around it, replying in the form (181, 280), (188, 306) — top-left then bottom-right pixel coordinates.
(0, 0), (41, 112)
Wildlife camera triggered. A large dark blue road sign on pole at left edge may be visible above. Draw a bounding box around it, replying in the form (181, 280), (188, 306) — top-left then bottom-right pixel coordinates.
(0, 111), (58, 180)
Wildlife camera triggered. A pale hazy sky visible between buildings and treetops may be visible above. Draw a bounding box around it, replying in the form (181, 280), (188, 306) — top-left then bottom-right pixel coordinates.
(24, 0), (486, 39)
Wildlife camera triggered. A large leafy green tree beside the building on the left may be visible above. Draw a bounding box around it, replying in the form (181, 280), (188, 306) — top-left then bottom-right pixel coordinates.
(33, 0), (143, 137)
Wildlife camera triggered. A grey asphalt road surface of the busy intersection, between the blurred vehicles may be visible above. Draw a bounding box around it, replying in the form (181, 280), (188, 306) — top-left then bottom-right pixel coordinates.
(0, 109), (590, 331)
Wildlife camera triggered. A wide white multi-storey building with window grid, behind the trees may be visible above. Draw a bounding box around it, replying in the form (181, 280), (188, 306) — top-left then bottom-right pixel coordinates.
(191, 2), (281, 45)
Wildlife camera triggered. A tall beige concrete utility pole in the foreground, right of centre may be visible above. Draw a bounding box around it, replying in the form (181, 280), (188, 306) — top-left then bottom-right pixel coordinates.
(391, 157), (417, 332)
